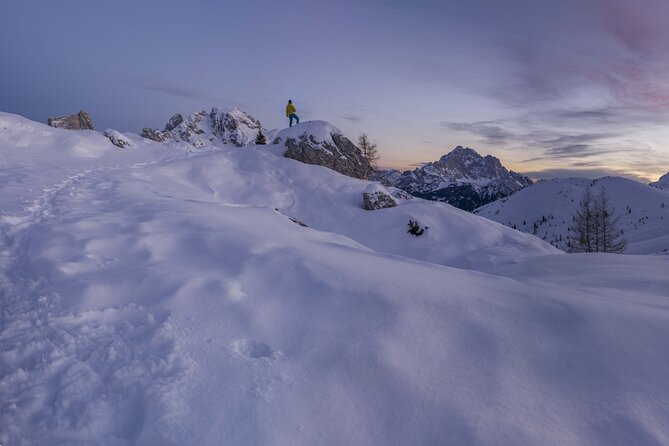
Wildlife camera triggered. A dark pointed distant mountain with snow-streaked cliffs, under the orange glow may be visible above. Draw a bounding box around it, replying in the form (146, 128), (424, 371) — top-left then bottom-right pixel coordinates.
(375, 146), (532, 211)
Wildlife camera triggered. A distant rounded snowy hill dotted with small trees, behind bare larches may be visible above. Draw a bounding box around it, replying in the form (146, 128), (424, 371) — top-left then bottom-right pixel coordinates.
(475, 177), (669, 254)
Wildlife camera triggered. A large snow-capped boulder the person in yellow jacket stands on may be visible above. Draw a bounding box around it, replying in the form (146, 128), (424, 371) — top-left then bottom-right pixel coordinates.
(273, 121), (369, 178)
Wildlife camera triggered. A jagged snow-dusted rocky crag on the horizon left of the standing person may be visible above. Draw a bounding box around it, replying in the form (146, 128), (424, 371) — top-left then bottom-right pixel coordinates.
(142, 107), (262, 147)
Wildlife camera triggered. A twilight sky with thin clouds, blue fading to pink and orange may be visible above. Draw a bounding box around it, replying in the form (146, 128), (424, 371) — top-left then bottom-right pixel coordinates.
(0, 0), (669, 180)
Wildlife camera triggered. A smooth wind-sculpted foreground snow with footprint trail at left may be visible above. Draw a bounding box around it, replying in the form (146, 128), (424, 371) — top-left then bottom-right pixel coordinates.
(0, 114), (669, 445)
